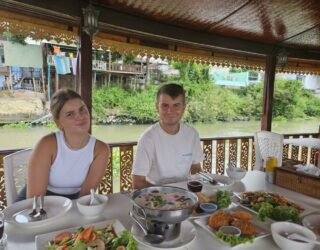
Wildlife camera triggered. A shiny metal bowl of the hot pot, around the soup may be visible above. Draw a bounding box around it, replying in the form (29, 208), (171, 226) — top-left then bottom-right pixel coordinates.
(131, 186), (198, 224)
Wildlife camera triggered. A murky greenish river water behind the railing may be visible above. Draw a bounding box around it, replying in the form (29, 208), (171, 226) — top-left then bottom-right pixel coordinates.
(0, 120), (320, 150)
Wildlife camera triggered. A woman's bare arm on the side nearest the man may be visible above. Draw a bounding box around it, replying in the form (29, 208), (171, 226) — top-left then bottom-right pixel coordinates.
(80, 140), (110, 196)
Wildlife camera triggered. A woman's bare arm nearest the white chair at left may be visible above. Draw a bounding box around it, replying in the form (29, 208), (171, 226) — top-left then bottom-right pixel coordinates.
(27, 134), (57, 198)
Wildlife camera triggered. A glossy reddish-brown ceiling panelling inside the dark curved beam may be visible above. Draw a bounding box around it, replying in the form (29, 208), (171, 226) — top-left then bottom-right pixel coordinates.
(99, 0), (320, 57)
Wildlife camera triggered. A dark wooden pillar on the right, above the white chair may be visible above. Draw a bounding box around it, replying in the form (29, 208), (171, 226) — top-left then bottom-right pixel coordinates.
(261, 55), (276, 131)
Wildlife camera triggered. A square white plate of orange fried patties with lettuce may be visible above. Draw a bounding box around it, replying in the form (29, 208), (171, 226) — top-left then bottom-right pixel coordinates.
(194, 205), (270, 247)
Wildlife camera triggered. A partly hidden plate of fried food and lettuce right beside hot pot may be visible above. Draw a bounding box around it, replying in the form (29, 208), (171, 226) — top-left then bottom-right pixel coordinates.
(189, 190), (232, 219)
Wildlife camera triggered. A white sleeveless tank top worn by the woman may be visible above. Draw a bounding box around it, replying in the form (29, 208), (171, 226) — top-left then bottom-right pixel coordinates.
(47, 131), (96, 194)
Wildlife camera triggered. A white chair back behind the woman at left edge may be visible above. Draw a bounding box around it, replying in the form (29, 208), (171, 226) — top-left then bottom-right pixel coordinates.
(3, 148), (32, 206)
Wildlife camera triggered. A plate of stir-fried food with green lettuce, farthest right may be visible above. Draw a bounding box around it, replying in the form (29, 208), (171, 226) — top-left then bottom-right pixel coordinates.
(236, 191), (304, 222)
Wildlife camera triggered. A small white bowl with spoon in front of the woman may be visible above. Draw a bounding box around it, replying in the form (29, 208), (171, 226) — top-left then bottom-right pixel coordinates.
(77, 194), (108, 217)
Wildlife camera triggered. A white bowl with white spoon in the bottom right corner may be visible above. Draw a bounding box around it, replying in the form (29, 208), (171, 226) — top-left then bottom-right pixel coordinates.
(271, 221), (317, 250)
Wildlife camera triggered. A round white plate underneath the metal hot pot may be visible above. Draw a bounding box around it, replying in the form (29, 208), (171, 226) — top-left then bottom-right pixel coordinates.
(131, 221), (197, 249)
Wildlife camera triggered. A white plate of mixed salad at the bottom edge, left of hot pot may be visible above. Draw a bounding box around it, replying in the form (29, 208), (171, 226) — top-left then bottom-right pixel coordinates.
(36, 220), (138, 250)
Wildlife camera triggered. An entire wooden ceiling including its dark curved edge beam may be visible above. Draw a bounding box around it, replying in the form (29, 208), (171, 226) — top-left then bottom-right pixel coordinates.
(0, 0), (320, 60)
